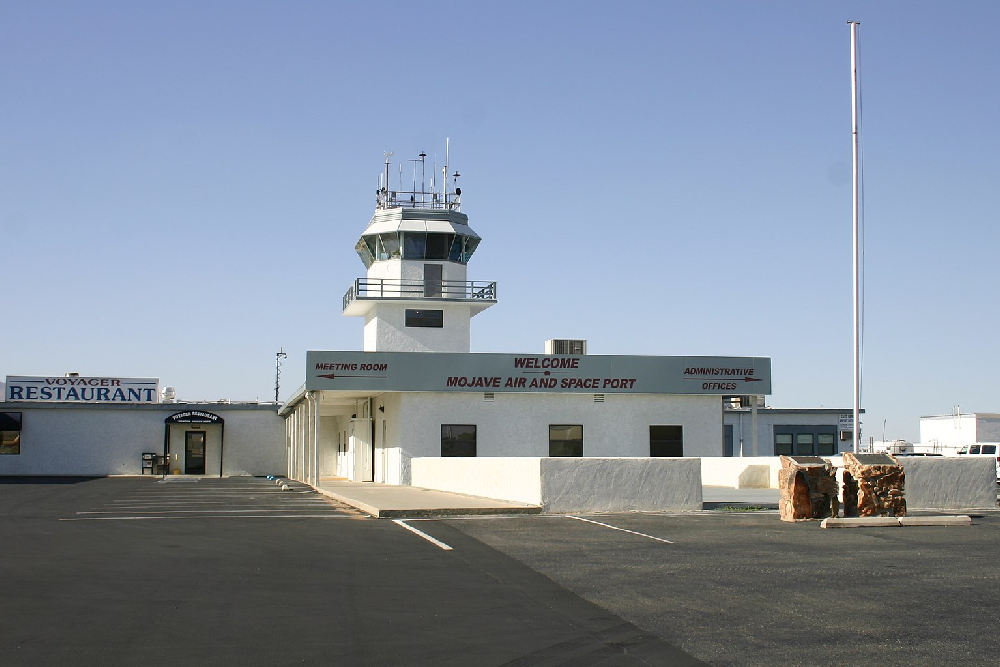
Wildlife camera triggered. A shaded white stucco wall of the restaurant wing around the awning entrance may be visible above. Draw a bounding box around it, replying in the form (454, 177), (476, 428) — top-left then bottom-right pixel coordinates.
(0, 403), (285, 475)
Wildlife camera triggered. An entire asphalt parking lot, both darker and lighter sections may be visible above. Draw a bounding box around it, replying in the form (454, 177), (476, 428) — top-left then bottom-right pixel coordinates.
(0, 478), (1000, 665)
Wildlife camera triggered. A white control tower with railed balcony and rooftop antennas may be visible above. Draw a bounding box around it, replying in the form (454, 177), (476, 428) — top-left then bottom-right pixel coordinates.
(344, 147), (497, 352)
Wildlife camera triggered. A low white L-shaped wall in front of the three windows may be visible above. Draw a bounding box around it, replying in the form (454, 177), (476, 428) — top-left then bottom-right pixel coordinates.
(411, 457), (702, 512)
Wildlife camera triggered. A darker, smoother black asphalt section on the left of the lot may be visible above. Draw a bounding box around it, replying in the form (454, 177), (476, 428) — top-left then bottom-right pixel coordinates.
(0, 478), (702, 667)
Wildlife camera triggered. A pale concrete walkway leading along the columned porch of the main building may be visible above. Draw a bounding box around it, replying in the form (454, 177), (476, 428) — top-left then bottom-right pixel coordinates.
(316, 477), (542, 519)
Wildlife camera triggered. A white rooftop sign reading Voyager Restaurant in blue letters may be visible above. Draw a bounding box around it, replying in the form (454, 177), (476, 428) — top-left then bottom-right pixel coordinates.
(5, 375), (160, 403)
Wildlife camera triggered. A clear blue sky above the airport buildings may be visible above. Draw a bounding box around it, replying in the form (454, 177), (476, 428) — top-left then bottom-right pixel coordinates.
(0, 0), (1000, 440)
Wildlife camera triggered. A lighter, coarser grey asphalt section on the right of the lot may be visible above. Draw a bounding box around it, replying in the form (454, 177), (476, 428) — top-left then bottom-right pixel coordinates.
(438, 512), (1000, 666)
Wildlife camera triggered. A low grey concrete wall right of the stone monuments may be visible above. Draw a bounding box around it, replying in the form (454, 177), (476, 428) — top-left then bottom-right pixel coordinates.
(897, 456), (997, 510)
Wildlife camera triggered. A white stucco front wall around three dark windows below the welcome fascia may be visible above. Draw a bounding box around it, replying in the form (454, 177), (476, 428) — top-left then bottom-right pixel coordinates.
(386, 392), (722, 458)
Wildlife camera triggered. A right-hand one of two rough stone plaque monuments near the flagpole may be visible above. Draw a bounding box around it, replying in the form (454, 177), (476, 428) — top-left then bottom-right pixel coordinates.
(844, 452), (906, 517)
